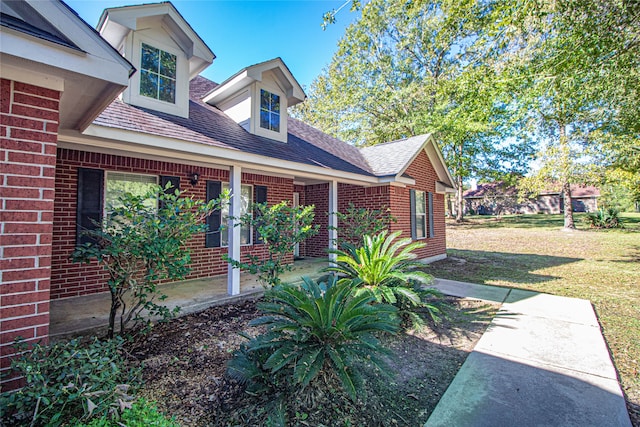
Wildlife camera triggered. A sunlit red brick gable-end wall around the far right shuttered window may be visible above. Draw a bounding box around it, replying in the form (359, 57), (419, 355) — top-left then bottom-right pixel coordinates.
(390, 151), (446, 259)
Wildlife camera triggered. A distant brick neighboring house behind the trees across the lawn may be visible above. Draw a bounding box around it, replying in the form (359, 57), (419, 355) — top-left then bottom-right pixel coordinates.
(462, 182), (600, 215)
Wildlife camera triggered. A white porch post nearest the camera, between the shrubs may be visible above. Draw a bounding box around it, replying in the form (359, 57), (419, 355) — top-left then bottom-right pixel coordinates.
(227, 166), (242, 295)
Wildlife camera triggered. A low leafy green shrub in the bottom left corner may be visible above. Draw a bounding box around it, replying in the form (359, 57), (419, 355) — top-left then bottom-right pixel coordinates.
(0, 337), (140, 426)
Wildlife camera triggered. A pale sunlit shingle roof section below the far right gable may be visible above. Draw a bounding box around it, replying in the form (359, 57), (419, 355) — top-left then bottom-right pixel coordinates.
(360, 135), (429, 176)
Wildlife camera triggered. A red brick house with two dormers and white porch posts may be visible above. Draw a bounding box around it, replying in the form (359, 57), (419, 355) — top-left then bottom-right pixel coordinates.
(0, 0), (453, 388)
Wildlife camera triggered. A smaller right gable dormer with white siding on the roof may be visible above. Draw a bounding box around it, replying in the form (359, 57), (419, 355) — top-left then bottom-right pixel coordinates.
(204, 58), (305, 142)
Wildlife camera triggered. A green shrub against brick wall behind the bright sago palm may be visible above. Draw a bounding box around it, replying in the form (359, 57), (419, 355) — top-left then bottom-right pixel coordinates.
(336, 202), (398, 247)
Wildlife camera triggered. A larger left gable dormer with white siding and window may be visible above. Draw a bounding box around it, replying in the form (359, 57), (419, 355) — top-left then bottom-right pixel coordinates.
(98, 2), (215, 117)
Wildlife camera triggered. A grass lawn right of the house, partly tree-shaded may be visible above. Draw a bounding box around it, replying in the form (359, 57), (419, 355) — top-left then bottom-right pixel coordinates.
(429, 214), (640, 425)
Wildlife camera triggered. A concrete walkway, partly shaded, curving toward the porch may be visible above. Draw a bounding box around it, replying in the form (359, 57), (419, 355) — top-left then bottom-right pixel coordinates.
(425, 279), (631, 427)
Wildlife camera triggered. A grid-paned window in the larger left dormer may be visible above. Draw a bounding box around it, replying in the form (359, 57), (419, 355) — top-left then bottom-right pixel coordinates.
(140, 43), (177, 104)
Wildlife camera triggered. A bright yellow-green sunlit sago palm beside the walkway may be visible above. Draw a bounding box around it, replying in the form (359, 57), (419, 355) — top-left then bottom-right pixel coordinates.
(326, 231), (440, 326)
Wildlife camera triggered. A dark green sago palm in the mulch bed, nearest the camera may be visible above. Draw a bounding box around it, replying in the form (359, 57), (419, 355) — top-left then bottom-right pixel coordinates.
(228, 278), (398, 401)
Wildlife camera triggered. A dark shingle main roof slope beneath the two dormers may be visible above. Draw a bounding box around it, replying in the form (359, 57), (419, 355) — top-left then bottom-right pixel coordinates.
(94, 76), (372, 175)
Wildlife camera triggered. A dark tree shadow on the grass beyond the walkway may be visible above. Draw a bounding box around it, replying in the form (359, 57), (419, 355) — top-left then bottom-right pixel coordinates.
(425, 249), (582, 284)
